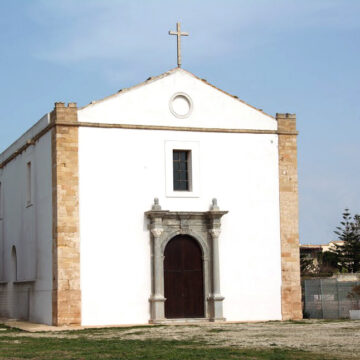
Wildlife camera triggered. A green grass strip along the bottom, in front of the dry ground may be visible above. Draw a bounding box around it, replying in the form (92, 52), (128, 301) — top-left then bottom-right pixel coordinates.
(0, 336), (342, 360)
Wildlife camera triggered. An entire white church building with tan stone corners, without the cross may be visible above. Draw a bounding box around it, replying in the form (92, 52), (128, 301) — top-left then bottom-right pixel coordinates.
(0, 68), (302, 325)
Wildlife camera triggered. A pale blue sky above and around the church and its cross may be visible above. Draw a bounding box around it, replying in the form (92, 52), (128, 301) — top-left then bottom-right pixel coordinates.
(0, 0), (360, 243)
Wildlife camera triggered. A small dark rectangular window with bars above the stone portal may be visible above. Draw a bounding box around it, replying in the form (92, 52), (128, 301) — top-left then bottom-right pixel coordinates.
(173, 150), (191, 191)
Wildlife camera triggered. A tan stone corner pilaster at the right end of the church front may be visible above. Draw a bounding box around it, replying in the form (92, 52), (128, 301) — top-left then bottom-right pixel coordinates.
(276, 114), (302, 320)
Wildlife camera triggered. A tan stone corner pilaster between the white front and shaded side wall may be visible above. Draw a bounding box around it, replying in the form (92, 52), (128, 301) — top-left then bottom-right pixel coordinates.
(50, 103), (81, 326)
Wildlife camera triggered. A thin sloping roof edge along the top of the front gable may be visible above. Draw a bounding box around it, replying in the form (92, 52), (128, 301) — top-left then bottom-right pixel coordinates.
(79, 67), (275, 119)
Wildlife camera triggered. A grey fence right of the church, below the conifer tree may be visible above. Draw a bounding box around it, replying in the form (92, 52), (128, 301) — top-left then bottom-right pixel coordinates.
(303, 279), (360, 319)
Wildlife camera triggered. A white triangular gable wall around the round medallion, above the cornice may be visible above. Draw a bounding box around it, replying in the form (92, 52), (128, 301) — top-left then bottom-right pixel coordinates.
(78, 69), (277, 130)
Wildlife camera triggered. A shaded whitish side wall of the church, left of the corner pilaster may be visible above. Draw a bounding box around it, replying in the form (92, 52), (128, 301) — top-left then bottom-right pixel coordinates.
(0, 131), (52, 324)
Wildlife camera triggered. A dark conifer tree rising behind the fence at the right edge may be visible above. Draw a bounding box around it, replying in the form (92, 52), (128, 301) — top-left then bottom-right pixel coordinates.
(333, 209), (360, 273)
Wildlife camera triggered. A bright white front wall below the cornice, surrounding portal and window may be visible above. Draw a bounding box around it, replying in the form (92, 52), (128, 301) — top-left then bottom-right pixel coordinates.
(79, 127), (281, 325)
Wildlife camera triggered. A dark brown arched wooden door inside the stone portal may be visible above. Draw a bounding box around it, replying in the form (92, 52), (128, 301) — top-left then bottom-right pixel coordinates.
(164, 235), (204, 319)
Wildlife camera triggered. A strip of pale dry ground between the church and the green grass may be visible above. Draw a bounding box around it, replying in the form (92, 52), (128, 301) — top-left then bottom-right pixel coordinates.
(0, 320), (360, 359)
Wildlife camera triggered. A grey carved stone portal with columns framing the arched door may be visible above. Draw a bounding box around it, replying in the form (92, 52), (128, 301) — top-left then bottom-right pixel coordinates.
(145, 198), (228, 323)
